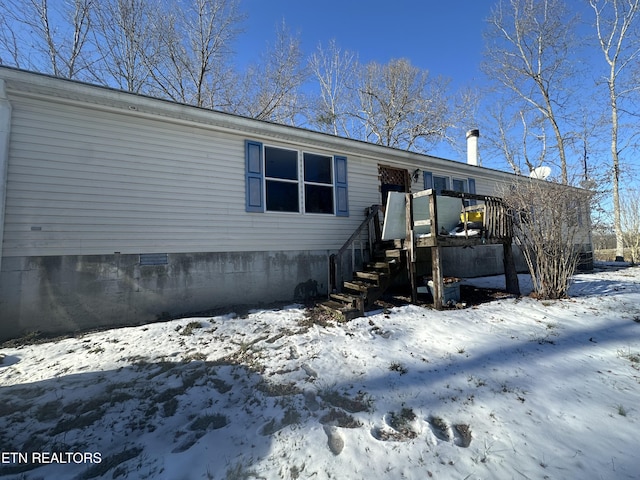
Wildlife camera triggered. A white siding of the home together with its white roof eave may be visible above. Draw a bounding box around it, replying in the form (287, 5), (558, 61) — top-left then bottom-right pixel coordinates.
(2, 70), (592, 262)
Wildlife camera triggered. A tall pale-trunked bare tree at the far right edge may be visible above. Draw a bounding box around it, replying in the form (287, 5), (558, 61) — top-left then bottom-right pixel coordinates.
(589, 0), (640, 261)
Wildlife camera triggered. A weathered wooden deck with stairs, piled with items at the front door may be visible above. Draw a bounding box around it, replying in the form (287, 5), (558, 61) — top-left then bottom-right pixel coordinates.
(322, 190), (520, 320)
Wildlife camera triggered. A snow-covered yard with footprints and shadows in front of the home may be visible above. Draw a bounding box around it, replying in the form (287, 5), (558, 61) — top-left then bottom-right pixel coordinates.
(0, 267), (640, 480)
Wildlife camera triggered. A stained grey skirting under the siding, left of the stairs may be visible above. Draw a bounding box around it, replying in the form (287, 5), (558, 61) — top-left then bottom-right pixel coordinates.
(0, 251), (329, 340)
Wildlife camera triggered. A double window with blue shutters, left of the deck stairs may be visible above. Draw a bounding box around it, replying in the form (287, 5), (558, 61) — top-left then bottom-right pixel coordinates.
(245, 141), (349, 216)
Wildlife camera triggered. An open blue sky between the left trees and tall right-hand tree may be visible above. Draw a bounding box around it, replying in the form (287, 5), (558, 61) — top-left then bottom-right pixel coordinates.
(237, 0), (495, 87)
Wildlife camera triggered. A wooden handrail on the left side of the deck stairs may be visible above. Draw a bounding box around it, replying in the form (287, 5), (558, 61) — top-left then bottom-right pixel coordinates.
(329, 205), (382, 293)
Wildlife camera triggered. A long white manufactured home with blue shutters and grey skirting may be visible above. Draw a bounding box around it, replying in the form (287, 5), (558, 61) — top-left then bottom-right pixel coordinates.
(0, 67), (592, 339)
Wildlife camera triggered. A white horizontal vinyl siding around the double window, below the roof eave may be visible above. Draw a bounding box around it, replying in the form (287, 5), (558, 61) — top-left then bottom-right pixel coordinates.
(3, 96), (379, 256)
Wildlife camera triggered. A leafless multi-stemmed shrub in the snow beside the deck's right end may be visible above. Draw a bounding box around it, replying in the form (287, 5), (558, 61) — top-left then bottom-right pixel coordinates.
(502, 178), (590, 299)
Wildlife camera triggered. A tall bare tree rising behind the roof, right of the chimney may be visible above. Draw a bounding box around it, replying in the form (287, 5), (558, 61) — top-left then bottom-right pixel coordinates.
(484, 0), (577, 184)
